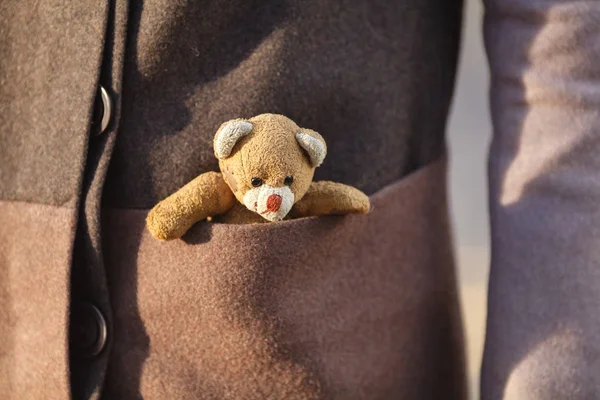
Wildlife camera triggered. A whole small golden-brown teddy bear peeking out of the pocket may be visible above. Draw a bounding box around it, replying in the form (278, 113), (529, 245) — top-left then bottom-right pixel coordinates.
(146, 114), (370, 240)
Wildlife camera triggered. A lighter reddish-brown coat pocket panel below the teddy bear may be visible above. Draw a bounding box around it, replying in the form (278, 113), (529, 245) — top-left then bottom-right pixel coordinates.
(104, 155), (464, 399)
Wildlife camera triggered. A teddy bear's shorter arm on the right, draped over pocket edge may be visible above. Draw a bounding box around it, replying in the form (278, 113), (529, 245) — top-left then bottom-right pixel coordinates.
(290, 181), (371, 218)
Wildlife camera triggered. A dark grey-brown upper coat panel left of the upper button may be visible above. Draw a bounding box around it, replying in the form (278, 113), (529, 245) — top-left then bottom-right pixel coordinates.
(0, 0), (107, 207)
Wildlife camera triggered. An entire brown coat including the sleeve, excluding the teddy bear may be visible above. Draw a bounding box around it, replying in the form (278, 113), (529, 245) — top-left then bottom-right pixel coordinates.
(8, 0), (600, 399)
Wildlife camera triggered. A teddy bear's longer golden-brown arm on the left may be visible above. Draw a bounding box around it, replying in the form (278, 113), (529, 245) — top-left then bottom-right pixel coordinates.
(146, 172), (235, 240)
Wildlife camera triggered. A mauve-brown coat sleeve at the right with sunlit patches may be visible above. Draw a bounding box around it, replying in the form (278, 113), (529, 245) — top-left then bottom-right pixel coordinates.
(481, 0), (600, 400)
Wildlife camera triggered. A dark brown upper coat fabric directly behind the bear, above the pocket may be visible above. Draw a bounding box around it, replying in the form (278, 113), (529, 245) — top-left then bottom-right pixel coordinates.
(105, 0), (462, 209)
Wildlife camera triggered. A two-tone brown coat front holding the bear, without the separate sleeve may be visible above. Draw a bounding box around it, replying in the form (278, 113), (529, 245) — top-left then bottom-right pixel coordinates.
(0, 0), (465, 400)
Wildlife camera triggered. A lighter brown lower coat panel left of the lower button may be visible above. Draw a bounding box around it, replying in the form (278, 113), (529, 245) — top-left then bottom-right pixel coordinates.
(0, 201), (77, 400)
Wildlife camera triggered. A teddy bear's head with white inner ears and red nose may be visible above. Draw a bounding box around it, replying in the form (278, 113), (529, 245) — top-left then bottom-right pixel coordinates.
(214, 114), (327, 221)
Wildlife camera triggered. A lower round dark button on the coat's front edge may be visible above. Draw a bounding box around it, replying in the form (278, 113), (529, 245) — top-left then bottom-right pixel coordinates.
(70, 302), (108, 358)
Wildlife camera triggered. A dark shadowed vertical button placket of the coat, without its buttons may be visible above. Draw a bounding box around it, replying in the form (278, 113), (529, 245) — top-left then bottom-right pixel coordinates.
(69, 0), (129, 400)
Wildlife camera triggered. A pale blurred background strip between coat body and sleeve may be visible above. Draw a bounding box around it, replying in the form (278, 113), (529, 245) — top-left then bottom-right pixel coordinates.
(448, 0), (491, 400)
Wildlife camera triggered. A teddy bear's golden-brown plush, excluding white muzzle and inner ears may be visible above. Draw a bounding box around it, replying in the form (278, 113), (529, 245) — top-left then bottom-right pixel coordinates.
(146, 114), (370, 240)
